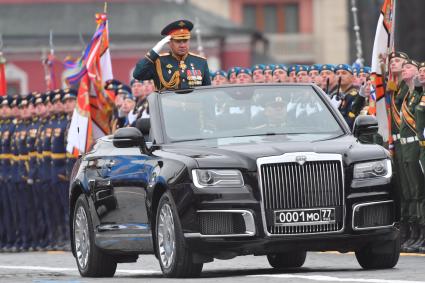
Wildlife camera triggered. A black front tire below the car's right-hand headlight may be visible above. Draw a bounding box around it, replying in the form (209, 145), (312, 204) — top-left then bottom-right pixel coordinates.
(356, 236), (400, 269)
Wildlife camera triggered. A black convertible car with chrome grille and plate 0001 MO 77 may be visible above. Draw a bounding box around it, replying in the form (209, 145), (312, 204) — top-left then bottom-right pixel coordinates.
(70, 84), (399, 277)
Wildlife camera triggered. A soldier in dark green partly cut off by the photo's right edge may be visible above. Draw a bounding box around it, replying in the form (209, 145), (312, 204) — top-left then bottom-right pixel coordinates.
(415, 62), (425, 253)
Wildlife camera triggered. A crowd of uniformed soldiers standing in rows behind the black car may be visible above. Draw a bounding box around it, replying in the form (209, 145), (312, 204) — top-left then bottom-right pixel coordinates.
(0, 52), (425, 253)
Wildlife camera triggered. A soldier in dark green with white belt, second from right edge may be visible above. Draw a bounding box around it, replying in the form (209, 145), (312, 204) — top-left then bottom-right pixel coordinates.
(400, 59), (425, 252)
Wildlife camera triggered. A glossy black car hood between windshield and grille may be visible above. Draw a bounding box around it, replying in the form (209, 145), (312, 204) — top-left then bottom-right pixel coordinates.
(158, 135), (388, 171)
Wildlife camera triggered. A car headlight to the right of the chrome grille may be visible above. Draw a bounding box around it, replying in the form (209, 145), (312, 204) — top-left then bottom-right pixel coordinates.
(351, 159), (392, 188)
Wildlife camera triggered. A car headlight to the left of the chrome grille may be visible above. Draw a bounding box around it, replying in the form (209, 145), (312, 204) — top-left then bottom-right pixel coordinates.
(192, 169), (244, 189)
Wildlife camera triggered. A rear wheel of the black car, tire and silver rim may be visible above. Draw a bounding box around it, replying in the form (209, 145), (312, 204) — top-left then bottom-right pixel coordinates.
(72, 194), (117, 277)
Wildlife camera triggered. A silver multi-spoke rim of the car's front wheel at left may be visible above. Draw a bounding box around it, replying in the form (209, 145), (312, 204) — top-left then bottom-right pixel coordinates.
(158, 204), (176, 268)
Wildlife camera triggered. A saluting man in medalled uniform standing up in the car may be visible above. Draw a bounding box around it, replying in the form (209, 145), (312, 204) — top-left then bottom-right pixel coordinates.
(133, 20), (211, 91)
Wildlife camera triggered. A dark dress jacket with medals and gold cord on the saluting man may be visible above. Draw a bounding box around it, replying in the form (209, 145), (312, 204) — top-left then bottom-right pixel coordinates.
(133, 49), (211, 91)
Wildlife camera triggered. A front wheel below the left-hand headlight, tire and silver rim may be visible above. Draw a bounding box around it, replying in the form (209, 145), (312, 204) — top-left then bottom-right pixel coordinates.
(155, 192), (203, 278)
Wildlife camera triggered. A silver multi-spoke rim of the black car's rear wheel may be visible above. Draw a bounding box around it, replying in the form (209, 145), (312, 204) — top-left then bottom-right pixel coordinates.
(74, 206), (90, 269)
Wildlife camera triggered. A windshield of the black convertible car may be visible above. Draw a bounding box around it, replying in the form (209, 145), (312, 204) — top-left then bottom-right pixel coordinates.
(160, 85), (344, 142)
